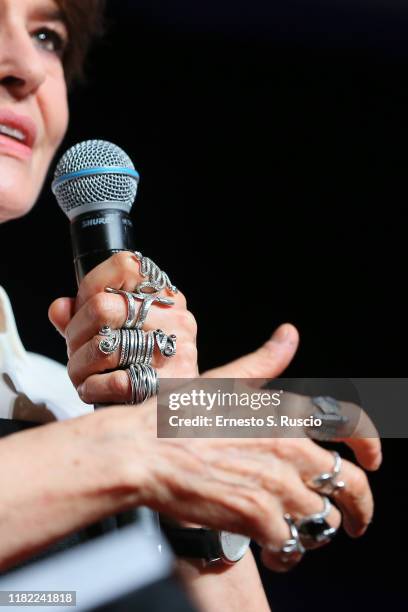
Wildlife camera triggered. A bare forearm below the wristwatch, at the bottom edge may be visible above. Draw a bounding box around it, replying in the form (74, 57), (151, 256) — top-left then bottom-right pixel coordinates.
(177, 551), (270, 612)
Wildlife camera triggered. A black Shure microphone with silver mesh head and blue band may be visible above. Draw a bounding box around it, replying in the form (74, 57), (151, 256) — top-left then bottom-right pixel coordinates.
(52, 140), (140, 284)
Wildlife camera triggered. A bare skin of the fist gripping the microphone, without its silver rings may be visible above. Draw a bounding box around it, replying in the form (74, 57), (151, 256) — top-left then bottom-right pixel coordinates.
(50, 252), (198, 403)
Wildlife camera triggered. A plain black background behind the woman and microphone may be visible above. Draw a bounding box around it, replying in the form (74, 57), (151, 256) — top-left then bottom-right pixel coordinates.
(0, 0), (408, 612)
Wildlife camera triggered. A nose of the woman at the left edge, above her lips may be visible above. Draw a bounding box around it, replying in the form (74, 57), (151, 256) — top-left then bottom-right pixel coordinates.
(0, 23), (46, 99)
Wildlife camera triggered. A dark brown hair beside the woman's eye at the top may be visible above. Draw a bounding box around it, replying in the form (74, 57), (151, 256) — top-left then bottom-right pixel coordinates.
(57, 0), (105, 85)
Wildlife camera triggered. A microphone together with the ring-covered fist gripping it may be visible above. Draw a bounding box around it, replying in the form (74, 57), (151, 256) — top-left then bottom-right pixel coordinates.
(50, 140), (198, 404)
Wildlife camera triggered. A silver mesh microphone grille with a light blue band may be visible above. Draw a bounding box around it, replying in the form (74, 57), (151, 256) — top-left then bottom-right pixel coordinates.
(52, 140), (139, 220)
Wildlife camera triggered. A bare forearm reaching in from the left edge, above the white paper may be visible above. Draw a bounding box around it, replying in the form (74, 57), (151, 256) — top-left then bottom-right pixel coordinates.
(0, 414), (145, 571)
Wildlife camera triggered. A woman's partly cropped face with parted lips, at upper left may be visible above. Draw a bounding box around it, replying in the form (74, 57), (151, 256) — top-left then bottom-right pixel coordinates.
(0, 0), (68, 222)
